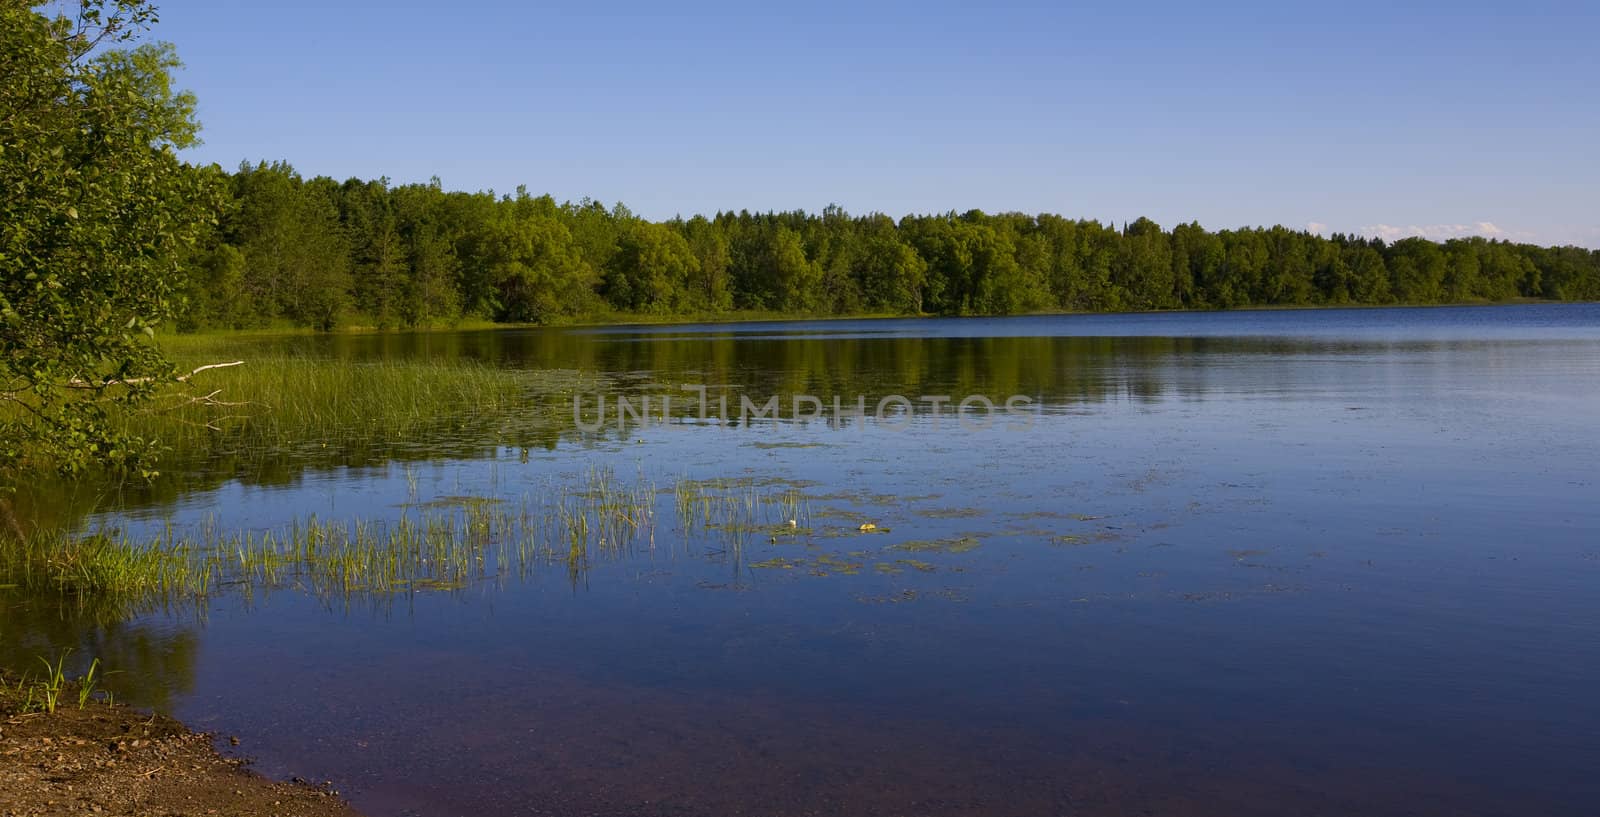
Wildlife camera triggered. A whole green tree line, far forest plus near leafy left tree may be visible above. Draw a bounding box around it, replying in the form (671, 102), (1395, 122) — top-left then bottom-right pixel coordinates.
(0, 0), (1600, 489)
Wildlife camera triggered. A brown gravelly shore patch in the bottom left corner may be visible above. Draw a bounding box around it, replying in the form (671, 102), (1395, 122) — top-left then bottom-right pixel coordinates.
(0, 673), (362, 817)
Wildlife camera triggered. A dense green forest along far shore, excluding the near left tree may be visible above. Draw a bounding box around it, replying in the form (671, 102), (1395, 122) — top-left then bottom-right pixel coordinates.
(179, 163), (1600, 329)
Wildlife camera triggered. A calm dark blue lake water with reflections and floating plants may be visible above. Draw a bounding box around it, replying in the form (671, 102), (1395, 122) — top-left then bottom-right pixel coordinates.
(0, 305), (1600, 817)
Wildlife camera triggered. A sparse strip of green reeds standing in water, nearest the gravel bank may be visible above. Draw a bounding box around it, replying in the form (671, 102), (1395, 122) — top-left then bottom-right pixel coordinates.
(0, 468), (832, 619)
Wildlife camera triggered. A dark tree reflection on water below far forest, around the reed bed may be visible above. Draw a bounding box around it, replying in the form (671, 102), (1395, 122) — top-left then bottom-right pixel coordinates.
(14, 329), (1466, 528)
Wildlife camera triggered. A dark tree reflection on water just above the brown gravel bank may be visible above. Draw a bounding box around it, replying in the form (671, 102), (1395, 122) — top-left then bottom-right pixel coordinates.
(0, 592), (200, 711)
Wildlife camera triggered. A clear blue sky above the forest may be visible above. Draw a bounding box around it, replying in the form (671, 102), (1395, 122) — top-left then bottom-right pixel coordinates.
(137, 0), (1600, 246)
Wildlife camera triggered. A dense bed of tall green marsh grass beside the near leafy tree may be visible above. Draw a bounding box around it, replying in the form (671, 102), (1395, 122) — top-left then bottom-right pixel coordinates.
(0, 336), (576, 482)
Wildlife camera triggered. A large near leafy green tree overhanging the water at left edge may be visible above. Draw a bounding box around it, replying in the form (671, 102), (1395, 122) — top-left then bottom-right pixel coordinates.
(0, 0), (222, 483)
